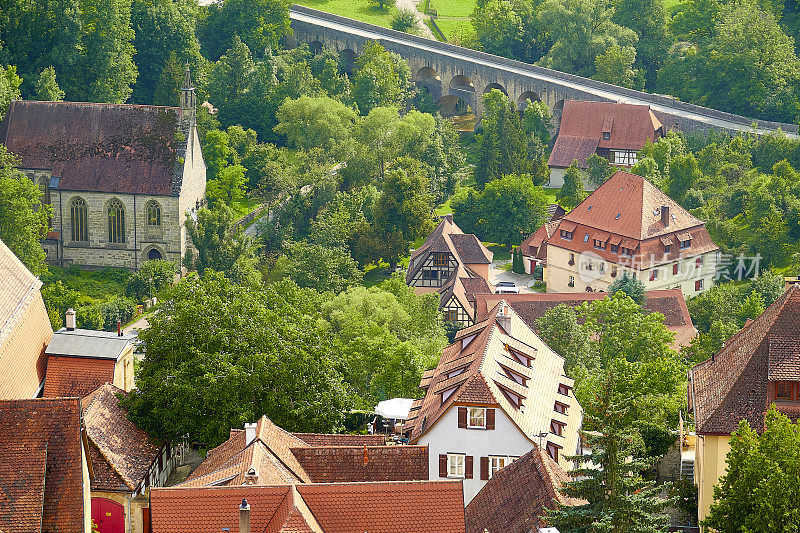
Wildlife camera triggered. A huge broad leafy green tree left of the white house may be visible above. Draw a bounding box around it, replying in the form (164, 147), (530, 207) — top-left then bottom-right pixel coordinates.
(123, 271), (351, 447)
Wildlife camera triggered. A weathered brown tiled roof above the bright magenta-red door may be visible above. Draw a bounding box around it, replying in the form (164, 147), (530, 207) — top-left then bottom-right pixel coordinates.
(84, 383), (160, 491)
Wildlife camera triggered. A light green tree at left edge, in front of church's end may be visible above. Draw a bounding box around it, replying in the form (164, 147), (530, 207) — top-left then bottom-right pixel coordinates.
(0, 145), (52, 276)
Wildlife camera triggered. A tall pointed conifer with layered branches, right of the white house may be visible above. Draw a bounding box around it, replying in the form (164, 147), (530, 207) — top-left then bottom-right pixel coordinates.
(547, 371), (670, 533)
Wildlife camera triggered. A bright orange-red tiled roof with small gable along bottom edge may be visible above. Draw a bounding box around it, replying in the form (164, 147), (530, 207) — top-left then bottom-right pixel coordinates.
(150, 481), (464, 533)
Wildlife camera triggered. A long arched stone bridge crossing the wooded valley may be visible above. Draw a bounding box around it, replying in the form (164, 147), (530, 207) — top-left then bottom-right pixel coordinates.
(289, 4), (798, 136)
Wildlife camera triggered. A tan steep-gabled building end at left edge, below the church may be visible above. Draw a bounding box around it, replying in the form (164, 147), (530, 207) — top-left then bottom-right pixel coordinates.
(0, 241), (53, 398)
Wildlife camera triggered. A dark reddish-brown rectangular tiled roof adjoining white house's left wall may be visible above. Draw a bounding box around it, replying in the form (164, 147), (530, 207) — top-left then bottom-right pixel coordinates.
(292, 446), (428, 483)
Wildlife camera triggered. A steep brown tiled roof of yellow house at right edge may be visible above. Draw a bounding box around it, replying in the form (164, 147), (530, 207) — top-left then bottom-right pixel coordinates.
(689, 286), (800, 435)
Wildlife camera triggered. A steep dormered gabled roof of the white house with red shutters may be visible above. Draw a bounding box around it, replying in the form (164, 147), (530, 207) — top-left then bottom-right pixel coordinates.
(404, 299), (580, 443)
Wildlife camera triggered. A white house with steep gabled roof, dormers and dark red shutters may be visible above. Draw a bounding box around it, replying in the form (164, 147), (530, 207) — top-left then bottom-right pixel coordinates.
(405, 301), (582, 504)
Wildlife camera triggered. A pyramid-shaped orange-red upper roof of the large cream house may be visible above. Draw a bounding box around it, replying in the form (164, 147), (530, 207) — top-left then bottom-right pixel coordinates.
(562, 171), (703, 239)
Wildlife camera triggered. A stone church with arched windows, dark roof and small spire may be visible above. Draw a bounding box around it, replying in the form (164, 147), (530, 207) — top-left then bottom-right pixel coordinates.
(0, 68), (206, 270)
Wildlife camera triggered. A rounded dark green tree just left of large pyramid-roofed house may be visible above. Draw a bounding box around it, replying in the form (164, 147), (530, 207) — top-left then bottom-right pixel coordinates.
(479, 174), (547, 247)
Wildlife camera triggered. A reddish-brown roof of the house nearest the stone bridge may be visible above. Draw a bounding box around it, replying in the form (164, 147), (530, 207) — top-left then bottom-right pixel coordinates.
(548, 100), (663, 167)
